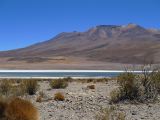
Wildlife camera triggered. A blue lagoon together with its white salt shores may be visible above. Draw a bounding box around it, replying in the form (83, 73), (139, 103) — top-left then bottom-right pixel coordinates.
(0, 70), (141, 78)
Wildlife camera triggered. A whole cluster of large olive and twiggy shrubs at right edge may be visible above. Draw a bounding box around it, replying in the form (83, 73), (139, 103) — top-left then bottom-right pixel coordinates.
(110, 71), (160, 103)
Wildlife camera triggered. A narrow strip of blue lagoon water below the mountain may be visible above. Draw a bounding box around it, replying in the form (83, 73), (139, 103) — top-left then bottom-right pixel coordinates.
(0, 71), (142, 77)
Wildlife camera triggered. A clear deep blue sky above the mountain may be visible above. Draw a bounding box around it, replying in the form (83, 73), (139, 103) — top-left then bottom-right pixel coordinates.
(0, 0), (160, 51)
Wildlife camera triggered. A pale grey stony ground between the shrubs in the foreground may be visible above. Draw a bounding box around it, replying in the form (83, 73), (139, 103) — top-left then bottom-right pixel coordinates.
(27, 81), (160, 120)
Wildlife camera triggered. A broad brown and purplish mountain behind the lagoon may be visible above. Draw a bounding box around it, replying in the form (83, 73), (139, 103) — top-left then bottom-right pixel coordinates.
(0, 24), (160, 69)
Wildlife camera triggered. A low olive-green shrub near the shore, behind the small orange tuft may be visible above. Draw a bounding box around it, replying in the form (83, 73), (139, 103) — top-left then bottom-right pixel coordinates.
(50, 79), (68, 89)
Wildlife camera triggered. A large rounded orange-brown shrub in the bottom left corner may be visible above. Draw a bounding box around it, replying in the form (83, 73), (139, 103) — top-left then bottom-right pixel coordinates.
(0, 98), (39, 120)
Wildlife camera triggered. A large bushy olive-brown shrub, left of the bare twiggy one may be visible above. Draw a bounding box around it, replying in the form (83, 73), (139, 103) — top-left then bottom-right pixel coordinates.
(110, 72), (141, 103)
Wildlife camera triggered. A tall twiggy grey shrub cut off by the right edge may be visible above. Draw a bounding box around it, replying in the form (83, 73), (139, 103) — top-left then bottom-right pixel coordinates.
(139, 65), (160, 102)
